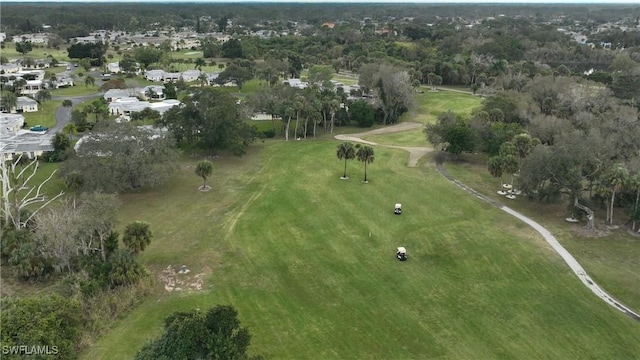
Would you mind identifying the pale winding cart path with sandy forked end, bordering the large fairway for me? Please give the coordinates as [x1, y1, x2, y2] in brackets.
[335, 122, 640, 322]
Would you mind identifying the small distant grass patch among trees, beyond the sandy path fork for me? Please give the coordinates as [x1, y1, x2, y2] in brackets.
[412, 87, 482, 123]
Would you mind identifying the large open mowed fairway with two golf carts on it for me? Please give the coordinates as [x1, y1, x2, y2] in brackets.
[82, 140, 640, 360]
